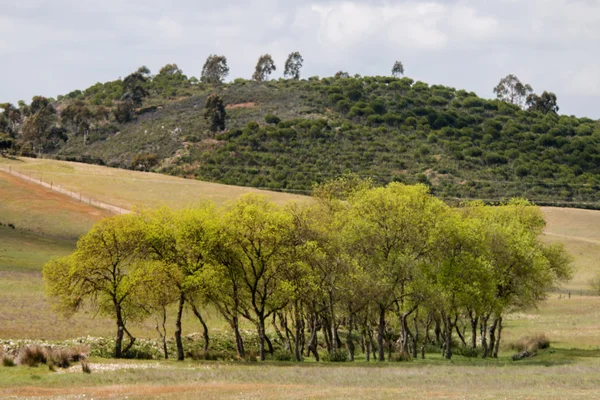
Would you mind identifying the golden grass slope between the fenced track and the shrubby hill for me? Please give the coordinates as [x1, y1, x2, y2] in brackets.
[0, 158, 308, 208]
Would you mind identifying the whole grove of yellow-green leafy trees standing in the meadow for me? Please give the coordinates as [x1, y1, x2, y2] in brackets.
[43, 180, 571, 361]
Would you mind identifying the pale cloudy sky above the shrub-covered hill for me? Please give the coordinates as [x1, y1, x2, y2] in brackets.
[0, 0, 600, 119]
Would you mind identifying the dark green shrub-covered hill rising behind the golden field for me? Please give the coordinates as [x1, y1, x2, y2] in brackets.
[0, 70, 600, 208]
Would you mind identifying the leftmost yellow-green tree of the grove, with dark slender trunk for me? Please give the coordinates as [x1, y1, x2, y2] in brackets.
[42, 214, 151, 358]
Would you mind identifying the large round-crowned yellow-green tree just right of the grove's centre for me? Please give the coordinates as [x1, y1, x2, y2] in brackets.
[346, 183, 447, 361]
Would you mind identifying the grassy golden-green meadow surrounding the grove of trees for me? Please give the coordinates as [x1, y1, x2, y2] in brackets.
[0, 158, 600, 399]
